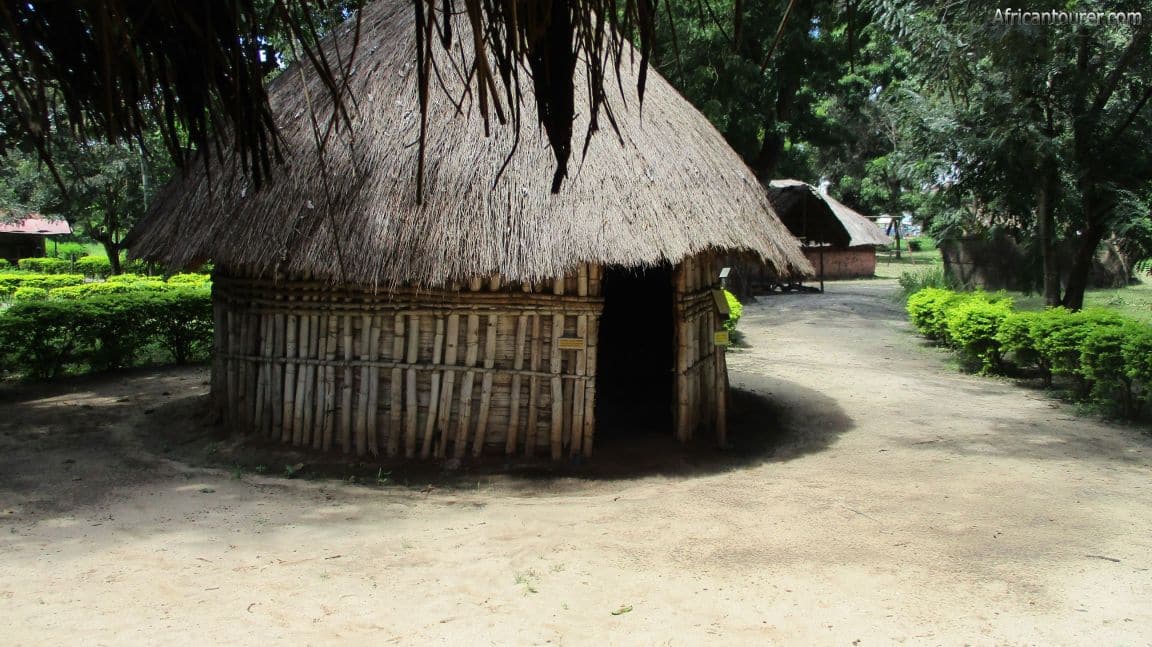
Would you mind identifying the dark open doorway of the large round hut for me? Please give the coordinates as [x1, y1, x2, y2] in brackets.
[596, 264, 676, 442]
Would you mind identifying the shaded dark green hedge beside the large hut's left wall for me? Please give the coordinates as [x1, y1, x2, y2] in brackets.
[0, 287, 212, 379]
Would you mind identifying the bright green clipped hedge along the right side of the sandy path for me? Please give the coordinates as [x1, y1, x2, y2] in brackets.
[907, 288, 1152, 417]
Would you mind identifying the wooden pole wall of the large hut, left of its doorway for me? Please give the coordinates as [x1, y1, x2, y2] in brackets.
[213, 265, 602, 458]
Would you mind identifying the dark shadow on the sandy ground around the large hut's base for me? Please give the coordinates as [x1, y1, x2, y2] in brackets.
[0, 370, 852, 513]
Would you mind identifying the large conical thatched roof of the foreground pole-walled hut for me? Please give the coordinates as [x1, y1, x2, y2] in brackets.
[131, 0, 811, 288]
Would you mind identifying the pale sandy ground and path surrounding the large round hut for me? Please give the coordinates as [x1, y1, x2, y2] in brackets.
[0, 281, 1152, 645]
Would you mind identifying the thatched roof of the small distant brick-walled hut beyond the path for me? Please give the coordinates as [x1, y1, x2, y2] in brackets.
[768, 180, 892, 248]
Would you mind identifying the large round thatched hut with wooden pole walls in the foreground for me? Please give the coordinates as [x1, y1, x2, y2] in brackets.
[131, 0, 811, 457]
